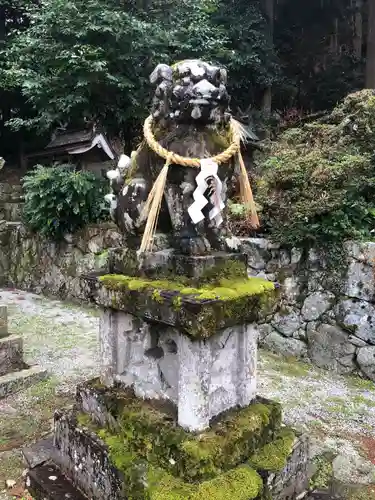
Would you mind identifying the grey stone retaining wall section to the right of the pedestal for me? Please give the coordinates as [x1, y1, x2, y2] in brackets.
[243, 238, 375, 380]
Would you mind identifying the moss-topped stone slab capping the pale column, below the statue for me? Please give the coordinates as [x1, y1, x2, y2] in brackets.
[89, 275, 277, 338]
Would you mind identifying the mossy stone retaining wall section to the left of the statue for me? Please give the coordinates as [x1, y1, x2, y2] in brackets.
[0, 221, 122, 300]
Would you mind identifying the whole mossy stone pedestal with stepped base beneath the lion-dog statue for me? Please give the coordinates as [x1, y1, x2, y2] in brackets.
[25, 250, 308, 500]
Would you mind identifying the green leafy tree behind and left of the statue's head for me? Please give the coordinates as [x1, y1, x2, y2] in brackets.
[3, 0, 271, 139]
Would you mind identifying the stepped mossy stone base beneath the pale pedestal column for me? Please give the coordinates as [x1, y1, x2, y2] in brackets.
[25, 380, 308, 500]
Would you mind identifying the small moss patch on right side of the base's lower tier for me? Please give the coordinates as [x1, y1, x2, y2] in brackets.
[248, 428, 296, 472]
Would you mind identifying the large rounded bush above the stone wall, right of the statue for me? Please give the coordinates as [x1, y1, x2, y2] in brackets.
[257, 90, 375, 247]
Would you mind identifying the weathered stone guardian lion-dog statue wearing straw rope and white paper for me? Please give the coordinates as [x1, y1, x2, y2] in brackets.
[106, 60, 257, 255]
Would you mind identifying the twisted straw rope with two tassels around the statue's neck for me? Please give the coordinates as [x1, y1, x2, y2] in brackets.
[139, 116, 259, 253]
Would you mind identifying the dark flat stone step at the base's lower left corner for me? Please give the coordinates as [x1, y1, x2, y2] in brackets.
[26, 462, 88, 500]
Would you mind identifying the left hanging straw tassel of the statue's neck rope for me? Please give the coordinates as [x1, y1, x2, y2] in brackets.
[139, 156, 171, 253]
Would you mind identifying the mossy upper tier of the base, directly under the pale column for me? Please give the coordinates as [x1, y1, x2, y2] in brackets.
[77, 381, 281, 482]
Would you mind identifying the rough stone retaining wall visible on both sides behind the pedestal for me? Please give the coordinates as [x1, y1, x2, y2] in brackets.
[0, 221, 375, 380]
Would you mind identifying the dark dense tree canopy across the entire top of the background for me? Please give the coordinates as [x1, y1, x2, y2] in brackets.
[0, 0, 375, 154]
